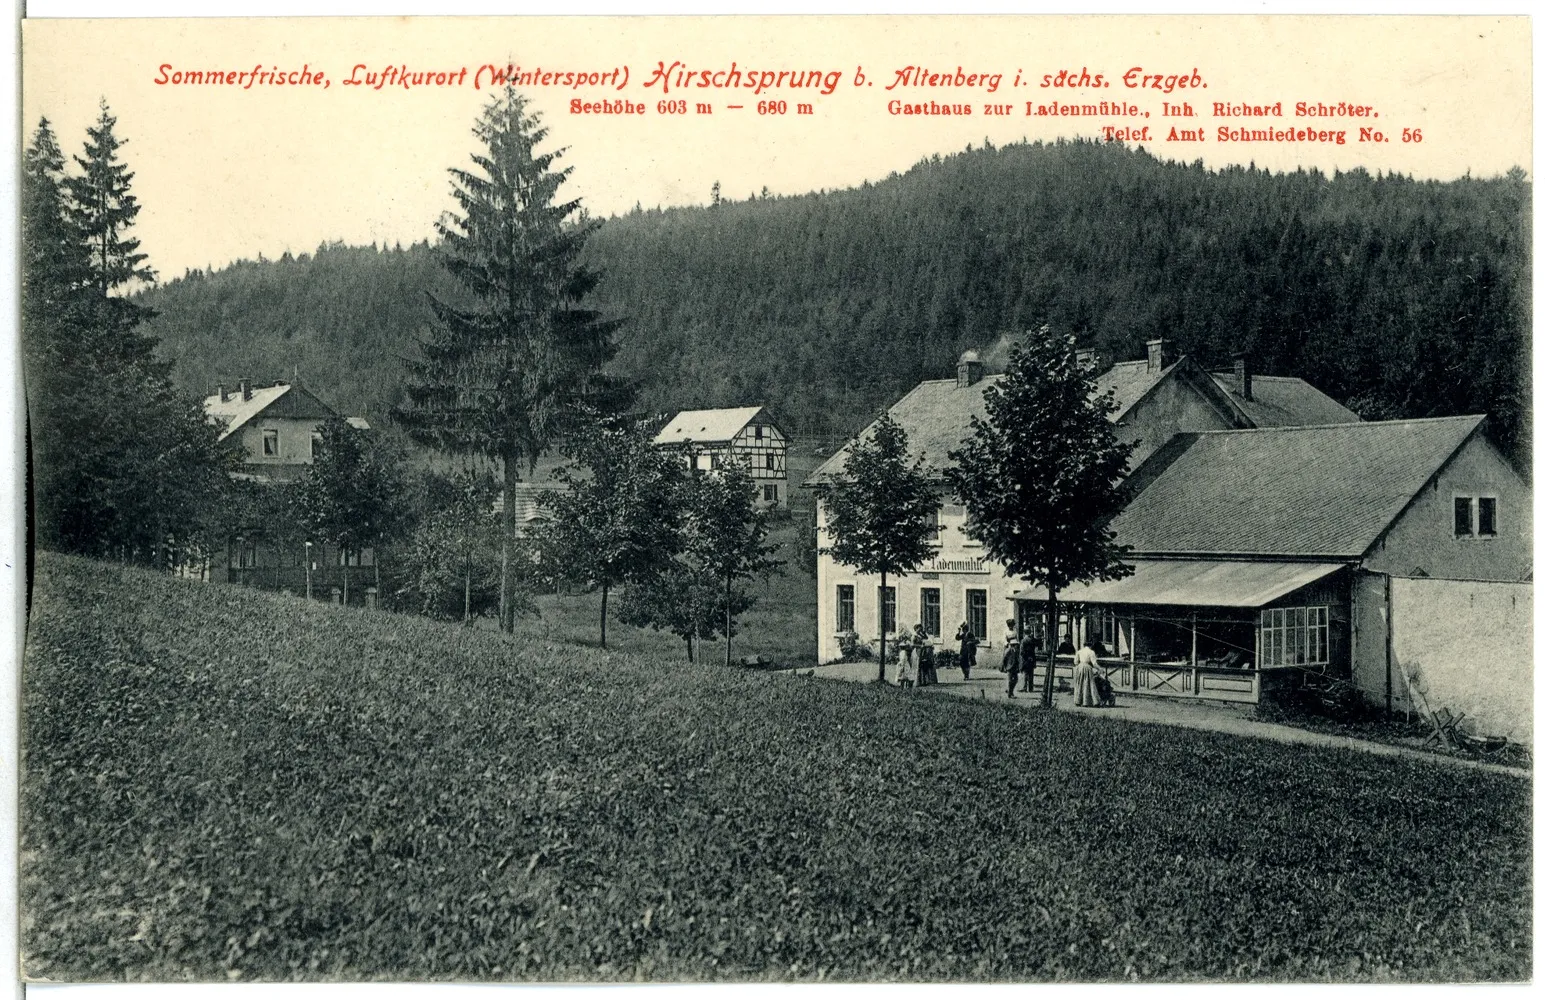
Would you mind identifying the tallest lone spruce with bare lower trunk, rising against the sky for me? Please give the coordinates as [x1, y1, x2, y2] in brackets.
[396, 88, 624, 631]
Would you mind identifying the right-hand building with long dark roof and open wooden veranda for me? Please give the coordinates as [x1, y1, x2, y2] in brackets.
[1014, 416, 1533, 711]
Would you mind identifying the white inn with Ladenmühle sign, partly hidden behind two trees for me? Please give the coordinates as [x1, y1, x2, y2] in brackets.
[806, 338, 1358, 663]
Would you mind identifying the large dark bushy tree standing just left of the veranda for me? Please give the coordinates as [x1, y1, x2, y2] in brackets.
[944, 326, 1132, 706]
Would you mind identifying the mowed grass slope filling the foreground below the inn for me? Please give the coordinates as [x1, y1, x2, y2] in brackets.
[22, 553, 1531, 980]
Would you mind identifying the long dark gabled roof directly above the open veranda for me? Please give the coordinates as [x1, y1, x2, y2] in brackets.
[1111, 416, 1485, 560]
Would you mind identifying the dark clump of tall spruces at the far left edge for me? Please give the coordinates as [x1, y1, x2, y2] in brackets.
[22, 112, 227, 566]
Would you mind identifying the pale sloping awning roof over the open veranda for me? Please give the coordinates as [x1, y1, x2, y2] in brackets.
[1009, 560, 1343, 607]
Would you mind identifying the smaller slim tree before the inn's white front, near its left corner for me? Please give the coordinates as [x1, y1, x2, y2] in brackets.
[816, 413, 939, 680]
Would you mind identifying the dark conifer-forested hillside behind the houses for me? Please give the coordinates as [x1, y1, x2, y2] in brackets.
[135, 142, 1531, 457]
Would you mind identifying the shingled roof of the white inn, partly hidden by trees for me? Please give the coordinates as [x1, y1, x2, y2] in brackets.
[805, 357, 1190, 484]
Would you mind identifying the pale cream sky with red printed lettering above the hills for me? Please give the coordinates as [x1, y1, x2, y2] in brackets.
[22, 17, 1533, 278]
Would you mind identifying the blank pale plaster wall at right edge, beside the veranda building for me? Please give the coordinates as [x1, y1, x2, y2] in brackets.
[1392, 578, 1534, 745]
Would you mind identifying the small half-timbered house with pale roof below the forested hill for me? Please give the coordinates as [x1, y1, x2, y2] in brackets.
[655, 406, 788, 507]
